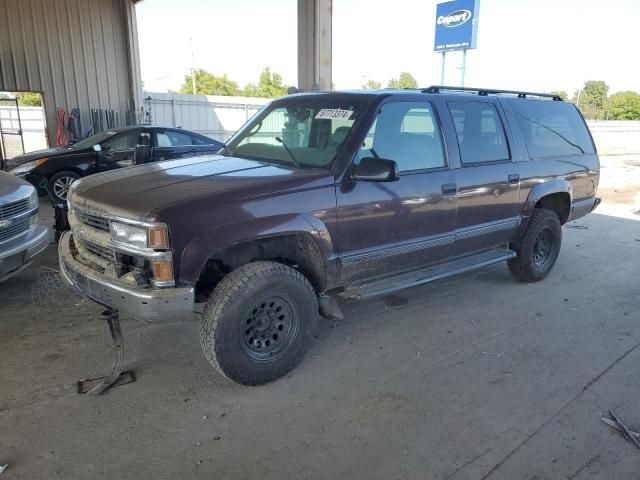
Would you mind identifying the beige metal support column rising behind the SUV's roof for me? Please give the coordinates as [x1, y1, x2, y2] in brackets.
[298, 0, 333, 91]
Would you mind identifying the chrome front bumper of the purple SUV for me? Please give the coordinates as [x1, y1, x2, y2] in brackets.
[58, 232, 194, 322]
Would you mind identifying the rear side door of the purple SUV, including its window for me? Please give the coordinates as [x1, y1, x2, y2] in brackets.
[447, 98, 520, 255]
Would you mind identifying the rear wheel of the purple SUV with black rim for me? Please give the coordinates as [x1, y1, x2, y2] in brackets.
[507, 208, 562, 283]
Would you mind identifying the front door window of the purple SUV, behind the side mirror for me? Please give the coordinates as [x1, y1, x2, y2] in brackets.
[358, 102, 446, 172]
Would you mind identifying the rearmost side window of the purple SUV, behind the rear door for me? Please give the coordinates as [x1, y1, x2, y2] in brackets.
[512, 100, 594, 158]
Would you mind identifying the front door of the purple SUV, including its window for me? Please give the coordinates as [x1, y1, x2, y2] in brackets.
[336, 101, 457, 284]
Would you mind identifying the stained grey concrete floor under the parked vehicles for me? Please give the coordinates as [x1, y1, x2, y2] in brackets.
[0, 157, 640, 480]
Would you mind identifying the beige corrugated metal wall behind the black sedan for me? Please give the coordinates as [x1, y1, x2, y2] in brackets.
[0, 0, 140, 145]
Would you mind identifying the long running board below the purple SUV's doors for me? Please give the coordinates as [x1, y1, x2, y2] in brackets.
[340, 248, 516, 300]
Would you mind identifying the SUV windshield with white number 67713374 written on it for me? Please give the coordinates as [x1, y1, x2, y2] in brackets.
[225, 95, 366, 168]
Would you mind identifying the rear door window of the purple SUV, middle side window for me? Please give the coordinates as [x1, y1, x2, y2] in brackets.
[448, 102, 510, 165]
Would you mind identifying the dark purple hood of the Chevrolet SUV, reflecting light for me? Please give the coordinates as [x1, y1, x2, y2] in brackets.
[71, 155, 333, 220]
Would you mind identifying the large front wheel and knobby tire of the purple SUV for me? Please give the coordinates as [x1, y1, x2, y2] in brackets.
[200, 261, 318, 385]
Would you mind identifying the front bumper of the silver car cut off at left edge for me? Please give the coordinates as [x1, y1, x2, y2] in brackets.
[0, 225, 49, 282]
